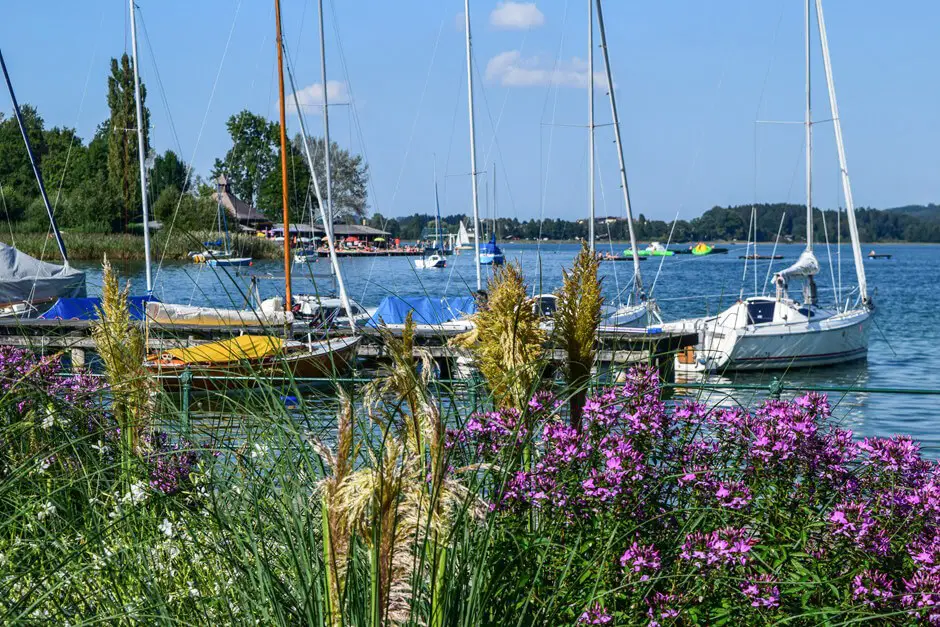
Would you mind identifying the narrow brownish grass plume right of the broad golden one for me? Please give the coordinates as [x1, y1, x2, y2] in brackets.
[555, 243, 604, 432]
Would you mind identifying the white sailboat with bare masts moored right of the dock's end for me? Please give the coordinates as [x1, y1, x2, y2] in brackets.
[664, 0, 873, 371]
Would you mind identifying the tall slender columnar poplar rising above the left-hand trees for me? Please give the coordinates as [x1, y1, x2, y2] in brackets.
[108, 53, 150, 229]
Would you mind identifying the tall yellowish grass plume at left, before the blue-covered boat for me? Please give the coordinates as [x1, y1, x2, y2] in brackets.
[91, 256, 152, 452]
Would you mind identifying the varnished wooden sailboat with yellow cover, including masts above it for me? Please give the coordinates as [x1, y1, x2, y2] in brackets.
[147, 0, 360, 388]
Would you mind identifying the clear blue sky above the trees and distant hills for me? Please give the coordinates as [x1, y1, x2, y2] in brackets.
[0, 0, 940, 220]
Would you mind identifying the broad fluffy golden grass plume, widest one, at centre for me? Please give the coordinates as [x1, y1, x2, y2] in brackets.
[454, 263, 546, 411]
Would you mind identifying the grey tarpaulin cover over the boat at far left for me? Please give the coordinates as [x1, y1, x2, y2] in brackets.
[0, 243, 85, 306]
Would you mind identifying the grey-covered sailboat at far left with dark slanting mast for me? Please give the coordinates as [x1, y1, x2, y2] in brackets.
[0, 47, 85, 317]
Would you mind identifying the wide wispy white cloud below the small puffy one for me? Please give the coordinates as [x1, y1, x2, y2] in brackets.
[486, 50, 607, 89]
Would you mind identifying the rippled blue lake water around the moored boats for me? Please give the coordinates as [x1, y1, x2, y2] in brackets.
[76, 244, 940, 456]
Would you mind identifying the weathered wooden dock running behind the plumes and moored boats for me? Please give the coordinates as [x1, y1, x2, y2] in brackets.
[0, 318, 698, 383]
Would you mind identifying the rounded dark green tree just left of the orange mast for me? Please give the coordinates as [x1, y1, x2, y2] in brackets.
[212, 110, 280, 206]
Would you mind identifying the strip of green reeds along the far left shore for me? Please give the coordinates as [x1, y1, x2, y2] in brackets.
[0, 231, 283, 261]
